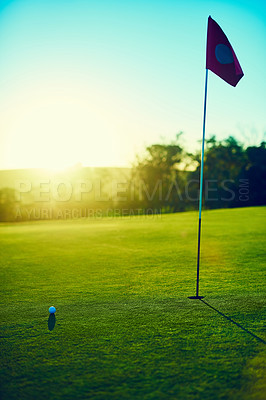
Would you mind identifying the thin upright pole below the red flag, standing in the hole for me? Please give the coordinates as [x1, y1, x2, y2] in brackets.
[189, 68, 208, 299]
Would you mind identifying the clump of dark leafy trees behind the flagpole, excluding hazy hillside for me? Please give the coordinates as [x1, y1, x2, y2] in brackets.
[132, 135, 266, 212]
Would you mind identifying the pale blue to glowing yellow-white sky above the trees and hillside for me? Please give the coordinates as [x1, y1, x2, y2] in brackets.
[0, 0, 266, 169]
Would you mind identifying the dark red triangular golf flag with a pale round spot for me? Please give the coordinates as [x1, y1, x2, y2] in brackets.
[206, 17, 244, 86]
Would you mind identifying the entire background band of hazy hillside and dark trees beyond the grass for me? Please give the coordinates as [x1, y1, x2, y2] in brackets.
[0, 134, 266, 221]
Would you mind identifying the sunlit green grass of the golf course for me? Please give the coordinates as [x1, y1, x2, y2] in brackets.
[0, 207, 266, 400]
